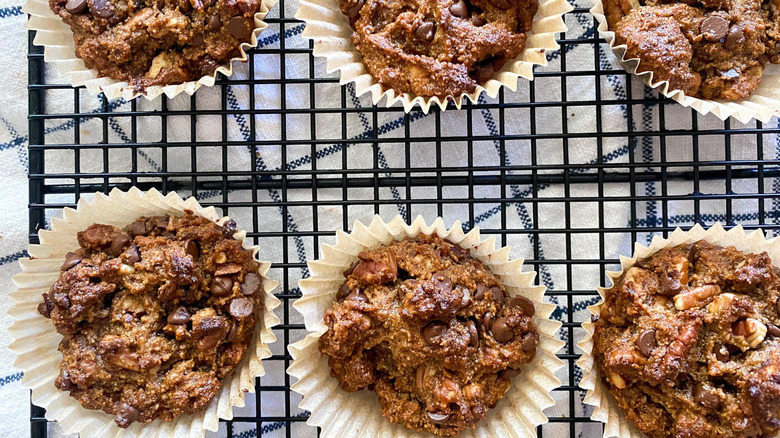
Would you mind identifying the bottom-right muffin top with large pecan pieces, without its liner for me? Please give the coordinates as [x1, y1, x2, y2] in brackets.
[593, 241, 780, 438]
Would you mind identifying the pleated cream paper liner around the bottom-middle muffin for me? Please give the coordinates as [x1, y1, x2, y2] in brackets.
[287, 216, 564, 438]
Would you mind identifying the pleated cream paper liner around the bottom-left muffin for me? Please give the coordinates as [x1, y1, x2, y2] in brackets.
[8, 188, 280, 437]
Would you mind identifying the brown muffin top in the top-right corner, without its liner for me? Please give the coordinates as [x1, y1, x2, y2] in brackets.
[604, 0, 780, 100]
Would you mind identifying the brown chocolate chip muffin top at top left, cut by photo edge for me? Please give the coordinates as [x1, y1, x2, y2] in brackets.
[49, 0, 262, 91]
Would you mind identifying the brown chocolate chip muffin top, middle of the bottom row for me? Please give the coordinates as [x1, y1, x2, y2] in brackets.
[319, 234, 539, 436]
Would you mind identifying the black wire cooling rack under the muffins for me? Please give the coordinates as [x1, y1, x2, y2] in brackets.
[29, 0, 780, 438]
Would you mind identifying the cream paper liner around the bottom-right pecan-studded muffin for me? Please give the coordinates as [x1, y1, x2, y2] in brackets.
[577, 223, 780, 438]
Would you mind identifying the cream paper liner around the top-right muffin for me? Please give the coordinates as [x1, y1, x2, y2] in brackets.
[590, 0, 780, 123]
